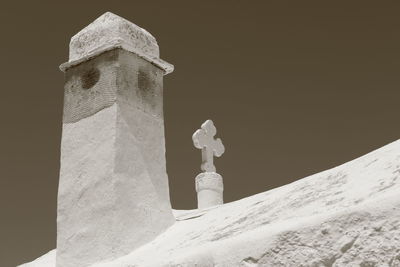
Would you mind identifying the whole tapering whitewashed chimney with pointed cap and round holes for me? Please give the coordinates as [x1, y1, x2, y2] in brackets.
[57, 12, 174, 267]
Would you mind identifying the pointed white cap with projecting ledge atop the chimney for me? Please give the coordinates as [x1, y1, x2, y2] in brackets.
[60, 12, 174, 74]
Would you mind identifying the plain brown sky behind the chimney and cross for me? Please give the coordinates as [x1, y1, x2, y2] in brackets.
[0, 1, 400, 267]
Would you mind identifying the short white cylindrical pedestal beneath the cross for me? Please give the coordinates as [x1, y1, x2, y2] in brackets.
[196, 172, 224, 209]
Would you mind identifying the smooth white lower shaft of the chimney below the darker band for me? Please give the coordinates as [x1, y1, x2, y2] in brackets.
[57, 104, 174, 267]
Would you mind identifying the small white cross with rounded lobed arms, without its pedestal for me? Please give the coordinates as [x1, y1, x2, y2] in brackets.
[192, 120, 225, 172]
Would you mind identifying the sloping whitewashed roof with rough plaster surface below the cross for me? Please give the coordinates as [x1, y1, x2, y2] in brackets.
[20, 141, 400, 267]
